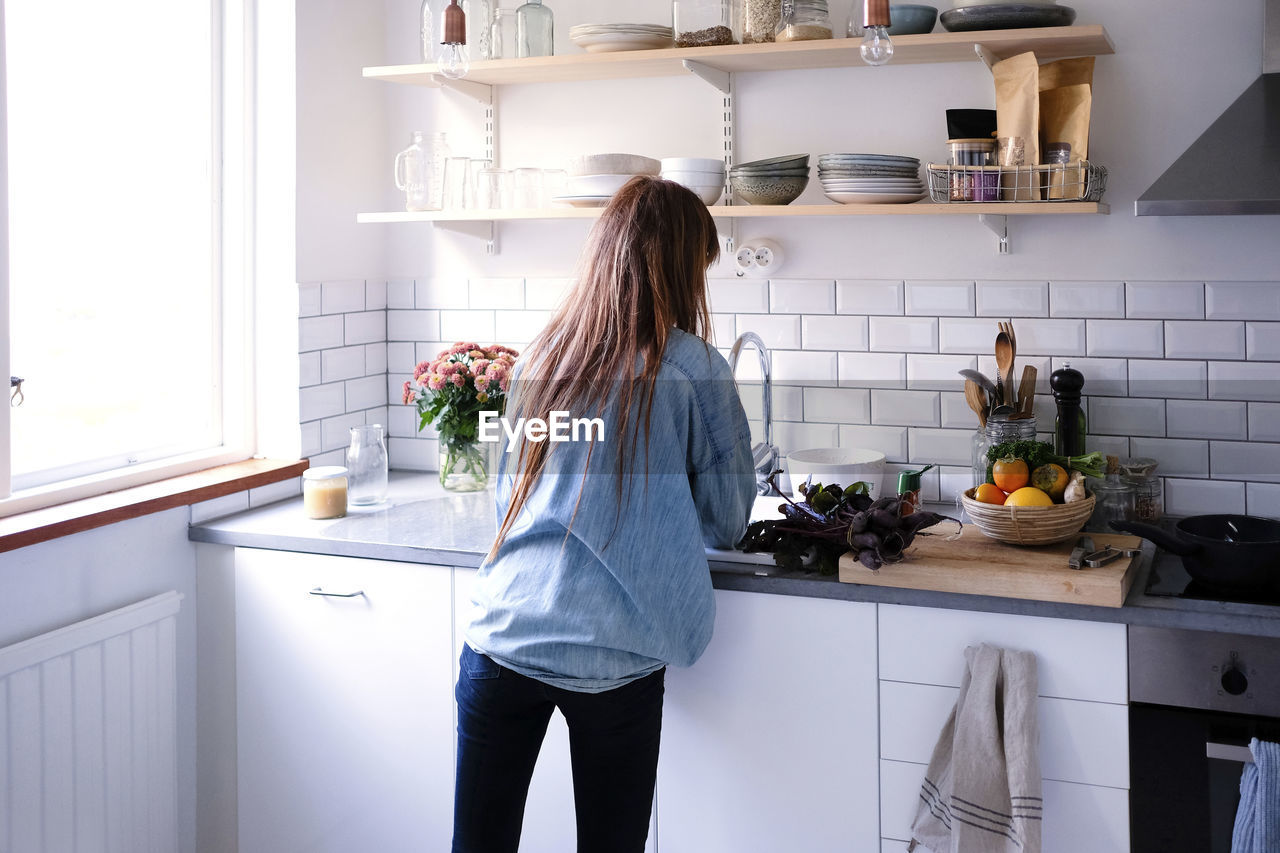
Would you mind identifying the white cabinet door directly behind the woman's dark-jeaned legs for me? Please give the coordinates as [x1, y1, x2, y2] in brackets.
[453, 567, 655, 853]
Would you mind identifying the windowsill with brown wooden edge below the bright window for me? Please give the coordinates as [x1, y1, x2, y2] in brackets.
[0, 459, 310, 552]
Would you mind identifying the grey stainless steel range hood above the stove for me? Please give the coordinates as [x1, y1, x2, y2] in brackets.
[1134, 0, 1280, 216]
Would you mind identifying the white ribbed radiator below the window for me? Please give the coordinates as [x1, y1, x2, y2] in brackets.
[0, 592, 182, 853]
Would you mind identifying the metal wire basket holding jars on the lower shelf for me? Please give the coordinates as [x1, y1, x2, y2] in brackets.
[928, 160, 1107, 204]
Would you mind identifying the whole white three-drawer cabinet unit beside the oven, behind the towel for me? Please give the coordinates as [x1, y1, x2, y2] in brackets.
[878, 605, 1129, 853]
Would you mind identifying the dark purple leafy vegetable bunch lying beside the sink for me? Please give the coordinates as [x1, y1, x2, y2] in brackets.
[737, 470, 960, 575]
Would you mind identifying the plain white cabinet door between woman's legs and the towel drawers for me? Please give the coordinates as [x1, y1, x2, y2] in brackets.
[658, 590, 879, 853]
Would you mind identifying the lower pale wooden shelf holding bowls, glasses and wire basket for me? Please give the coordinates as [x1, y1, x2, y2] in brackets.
[356, 201, 1111, 223]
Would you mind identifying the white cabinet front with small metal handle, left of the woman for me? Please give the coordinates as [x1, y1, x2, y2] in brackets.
[236, 548, 453, 853]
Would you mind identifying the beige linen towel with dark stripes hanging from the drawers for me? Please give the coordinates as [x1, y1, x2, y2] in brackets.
[908, 643, 1039, 853]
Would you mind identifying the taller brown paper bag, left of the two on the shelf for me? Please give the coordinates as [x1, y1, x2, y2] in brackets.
[991, 51, 1039, 201]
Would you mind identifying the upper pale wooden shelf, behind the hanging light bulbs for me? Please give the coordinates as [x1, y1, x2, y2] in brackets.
[364, 24, 1115, 87]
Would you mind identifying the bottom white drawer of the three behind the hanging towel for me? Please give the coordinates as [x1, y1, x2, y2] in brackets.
[881, 761, 1129, 853]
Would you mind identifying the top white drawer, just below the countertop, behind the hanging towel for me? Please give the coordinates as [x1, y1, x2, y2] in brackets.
[879, 605, 1129, 704]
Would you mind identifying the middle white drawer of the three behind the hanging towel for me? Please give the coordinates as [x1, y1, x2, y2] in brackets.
[881, 681, 1129, 788]
